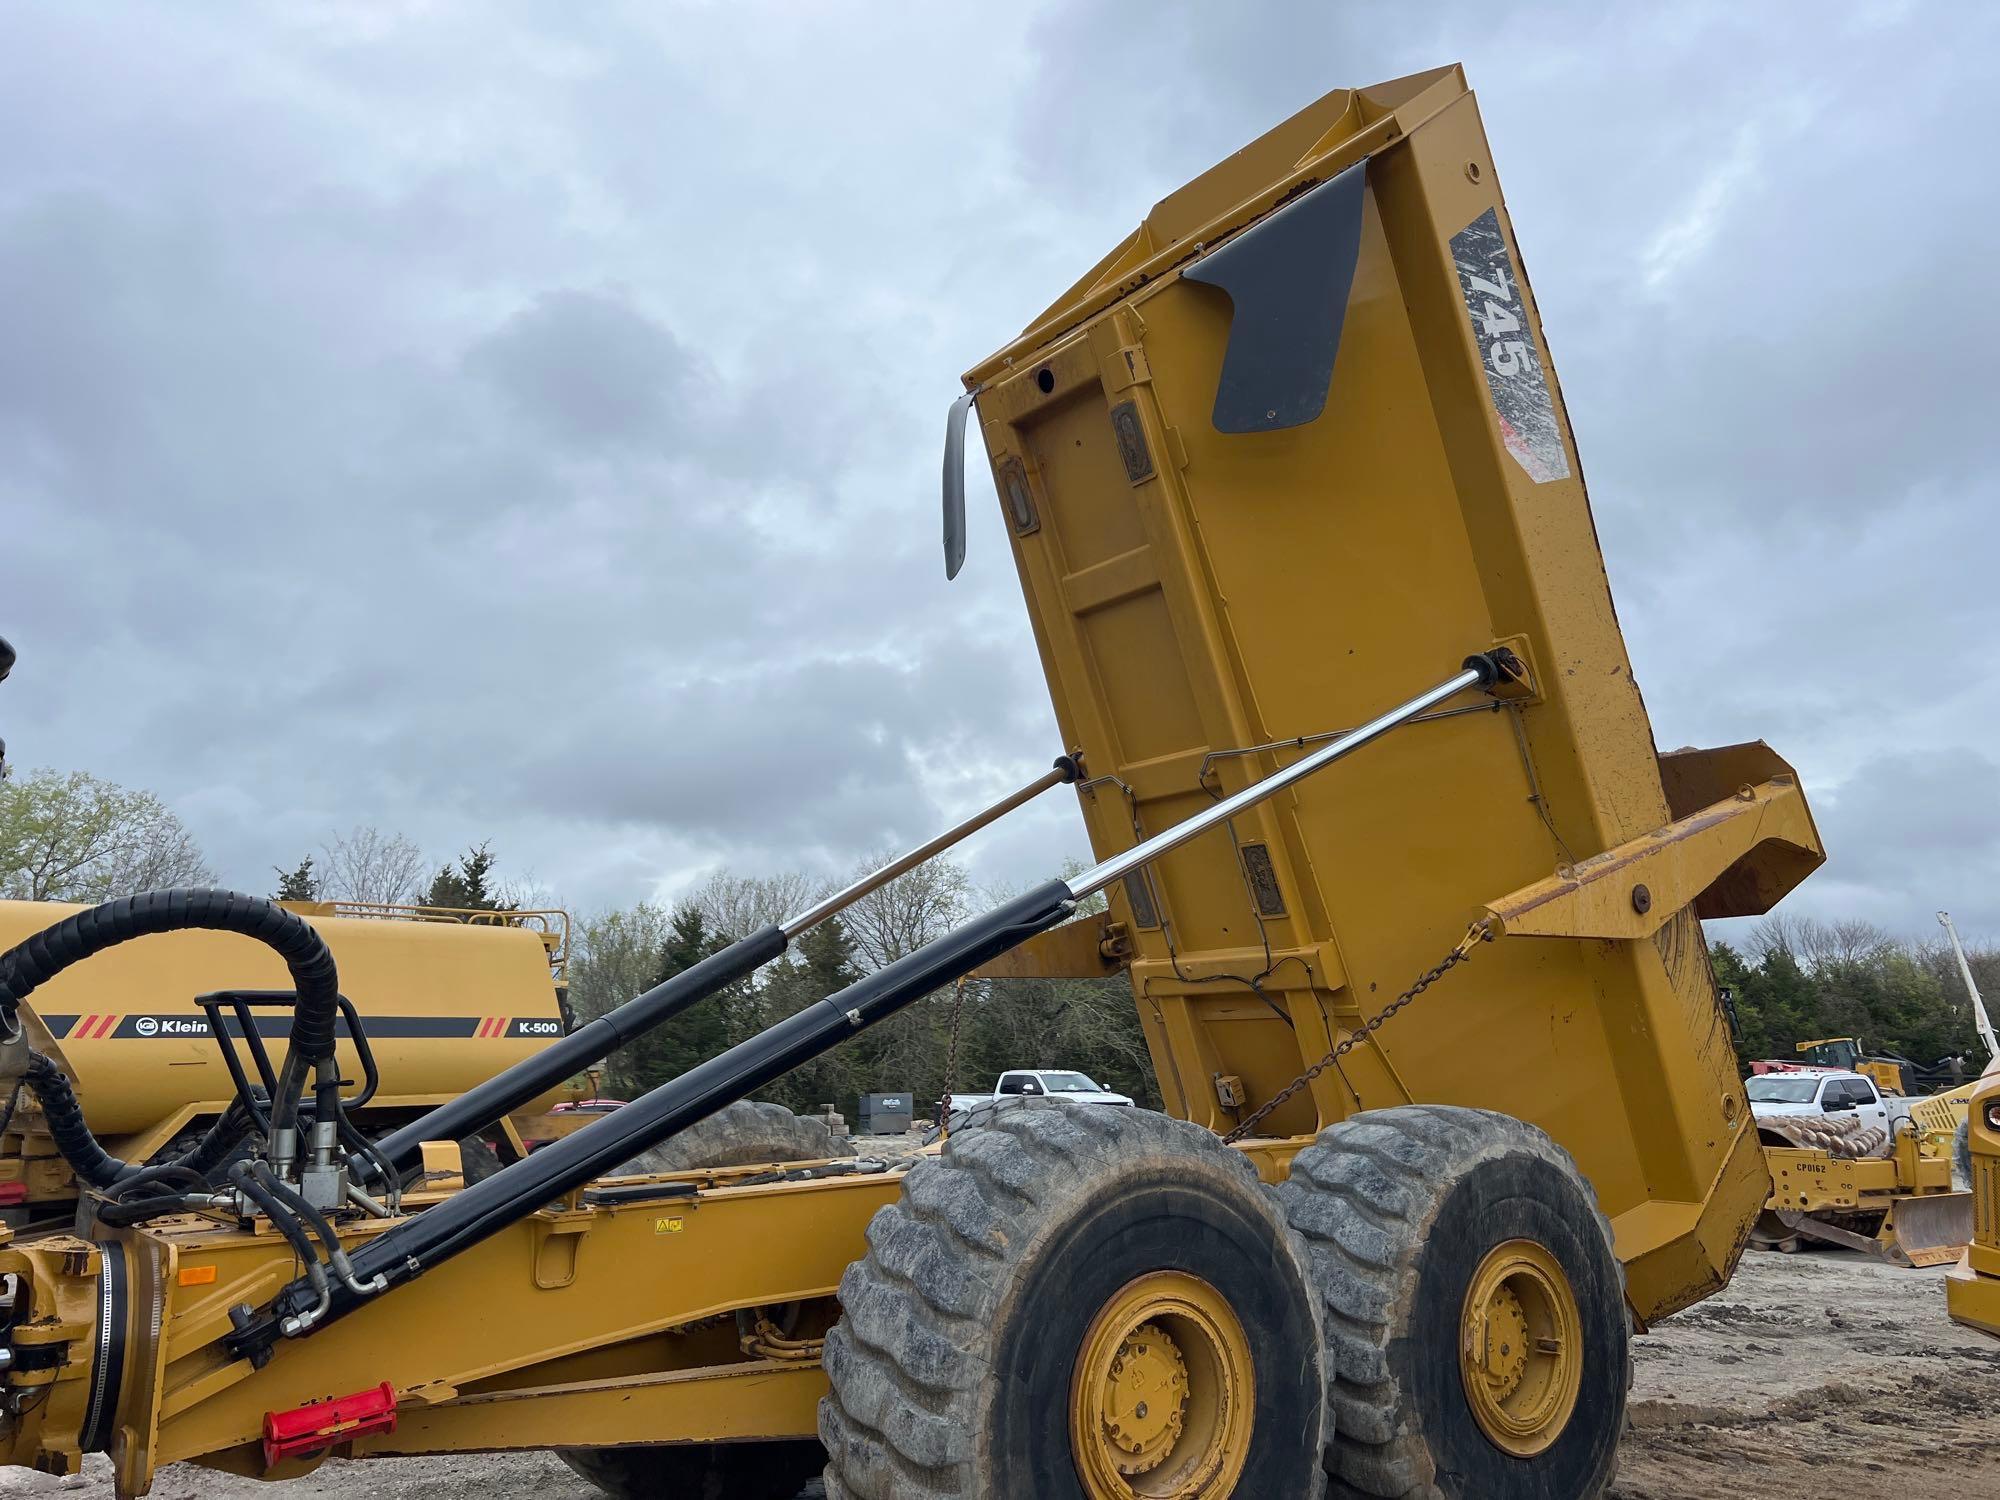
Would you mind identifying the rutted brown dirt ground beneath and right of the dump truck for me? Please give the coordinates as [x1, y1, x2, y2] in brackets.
[0, 1252, 2000, 1500]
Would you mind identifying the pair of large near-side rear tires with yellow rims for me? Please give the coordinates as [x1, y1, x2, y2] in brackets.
[820, 1100, 1630, 1500]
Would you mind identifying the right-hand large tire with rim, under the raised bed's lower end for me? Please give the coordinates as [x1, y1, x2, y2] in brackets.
[1278, 1104, 1632, 1500]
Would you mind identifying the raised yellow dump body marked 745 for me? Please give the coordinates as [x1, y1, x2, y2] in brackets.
[966, 68, 1822, 1318]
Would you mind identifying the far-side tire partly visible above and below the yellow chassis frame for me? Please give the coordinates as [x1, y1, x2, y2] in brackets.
[556, 1100, 854, 1500]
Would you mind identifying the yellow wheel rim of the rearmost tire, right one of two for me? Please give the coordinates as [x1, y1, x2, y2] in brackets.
[1458, 1240, 1584, 1458]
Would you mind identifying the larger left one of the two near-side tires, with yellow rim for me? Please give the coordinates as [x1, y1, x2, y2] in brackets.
[820, 1098, 1322, 1500]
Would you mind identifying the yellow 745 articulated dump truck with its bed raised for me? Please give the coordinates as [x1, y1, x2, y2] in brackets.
[0, 68, 1822, 1500]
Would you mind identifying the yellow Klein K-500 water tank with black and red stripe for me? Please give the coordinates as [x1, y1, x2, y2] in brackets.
[0, 902, 562, 1176]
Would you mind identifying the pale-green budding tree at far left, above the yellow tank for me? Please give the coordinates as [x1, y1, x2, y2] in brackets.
[0, 770, 216, 902]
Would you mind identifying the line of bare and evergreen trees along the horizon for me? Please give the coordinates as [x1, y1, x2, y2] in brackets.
[0, 770, 2000, 1114]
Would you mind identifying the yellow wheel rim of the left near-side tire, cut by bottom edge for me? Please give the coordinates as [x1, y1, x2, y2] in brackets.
[1070, 1270, 1256, 1500]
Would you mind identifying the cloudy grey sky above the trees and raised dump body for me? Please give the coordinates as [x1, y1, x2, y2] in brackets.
[0, 0, 2000, 936]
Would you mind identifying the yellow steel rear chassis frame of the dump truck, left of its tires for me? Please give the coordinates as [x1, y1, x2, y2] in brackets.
[0, 1168, 902, 1492]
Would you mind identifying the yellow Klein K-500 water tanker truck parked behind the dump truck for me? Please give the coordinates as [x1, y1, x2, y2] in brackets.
[0, 902, 568, 1232]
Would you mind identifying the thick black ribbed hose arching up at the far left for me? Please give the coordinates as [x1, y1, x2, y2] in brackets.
[0, 890, 340, 1188]
